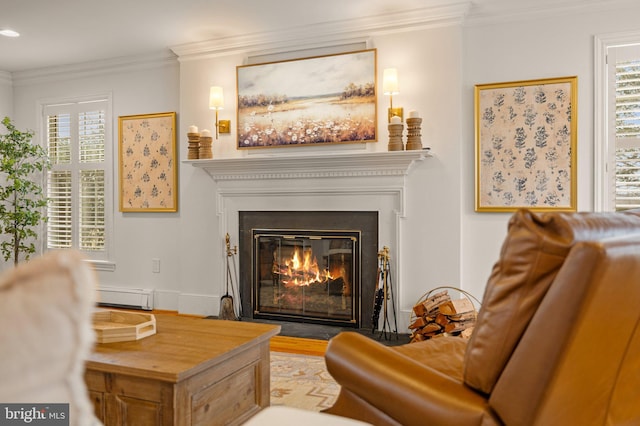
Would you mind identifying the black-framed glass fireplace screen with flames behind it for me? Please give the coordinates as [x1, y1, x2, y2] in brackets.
[252, 229, 360, 326]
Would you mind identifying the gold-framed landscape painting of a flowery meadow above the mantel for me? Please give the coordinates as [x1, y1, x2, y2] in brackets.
[236, 49, 377, 149]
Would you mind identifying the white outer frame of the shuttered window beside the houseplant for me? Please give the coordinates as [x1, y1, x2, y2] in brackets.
[38, 92, 115, 271]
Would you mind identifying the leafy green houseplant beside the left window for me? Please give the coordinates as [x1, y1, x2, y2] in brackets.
[0, 117, 50, 265]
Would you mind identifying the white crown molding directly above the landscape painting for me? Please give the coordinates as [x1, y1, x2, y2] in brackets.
[170, 0, 471, 61]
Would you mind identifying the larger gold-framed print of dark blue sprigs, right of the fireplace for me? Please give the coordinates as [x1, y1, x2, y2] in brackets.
[474, 76, 578, 212]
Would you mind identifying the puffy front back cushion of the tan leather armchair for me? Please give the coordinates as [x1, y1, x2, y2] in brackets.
[464, 210, 640, 394]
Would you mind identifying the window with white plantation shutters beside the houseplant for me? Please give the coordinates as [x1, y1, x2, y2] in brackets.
[43, 98, 112, 261]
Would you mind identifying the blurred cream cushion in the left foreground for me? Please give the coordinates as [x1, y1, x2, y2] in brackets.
[0, 251, 98, 426]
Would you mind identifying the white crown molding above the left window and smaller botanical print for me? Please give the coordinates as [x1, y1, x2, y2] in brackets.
[12, 49, 177, 86]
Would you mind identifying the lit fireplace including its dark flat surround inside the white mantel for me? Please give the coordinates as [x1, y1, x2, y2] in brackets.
[239, 211, 378, 327]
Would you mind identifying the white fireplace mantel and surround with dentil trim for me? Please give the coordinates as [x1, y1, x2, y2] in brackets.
[184, 150, 430, 330]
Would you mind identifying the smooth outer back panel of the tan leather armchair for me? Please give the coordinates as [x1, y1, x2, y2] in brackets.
[489, 233, 640, 426]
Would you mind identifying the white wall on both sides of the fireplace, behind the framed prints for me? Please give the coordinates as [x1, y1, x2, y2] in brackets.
[8, 3, 640, 315]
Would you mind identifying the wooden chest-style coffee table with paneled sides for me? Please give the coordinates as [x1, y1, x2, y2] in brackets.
[85, 314, 280, 426]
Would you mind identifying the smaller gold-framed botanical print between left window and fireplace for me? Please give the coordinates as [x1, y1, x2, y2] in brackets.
[118, 112, 178, 212]
